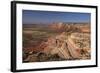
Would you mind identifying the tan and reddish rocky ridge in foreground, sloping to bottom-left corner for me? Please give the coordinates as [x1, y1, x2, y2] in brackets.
[24, 32, 89, 62]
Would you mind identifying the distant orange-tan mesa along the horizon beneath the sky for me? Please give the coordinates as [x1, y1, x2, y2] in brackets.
[49, 22, 90, 32]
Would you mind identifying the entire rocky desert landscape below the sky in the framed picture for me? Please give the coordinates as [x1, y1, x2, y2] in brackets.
[22, 22, 91, 63]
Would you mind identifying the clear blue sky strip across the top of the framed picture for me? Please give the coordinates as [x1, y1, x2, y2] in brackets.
[22, 10, 91, 24]
